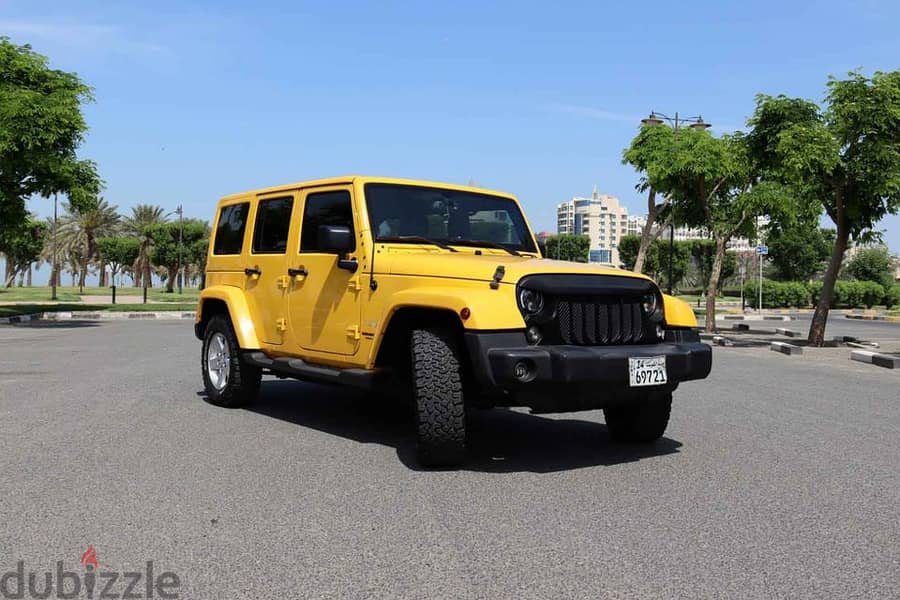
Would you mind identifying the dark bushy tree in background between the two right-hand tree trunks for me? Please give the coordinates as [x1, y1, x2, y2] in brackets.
[766, 223, 834, 281]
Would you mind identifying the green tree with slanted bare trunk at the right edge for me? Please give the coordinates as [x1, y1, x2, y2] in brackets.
[751, 71, 900, 346]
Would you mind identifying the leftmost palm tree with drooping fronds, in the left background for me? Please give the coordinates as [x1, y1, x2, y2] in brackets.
[57, 198, 121, 288]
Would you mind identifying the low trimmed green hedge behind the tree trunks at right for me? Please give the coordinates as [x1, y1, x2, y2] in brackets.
[744, 279, 900, 308]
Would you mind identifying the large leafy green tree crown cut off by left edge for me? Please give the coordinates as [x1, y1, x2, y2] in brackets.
[0, 37, 100, 235]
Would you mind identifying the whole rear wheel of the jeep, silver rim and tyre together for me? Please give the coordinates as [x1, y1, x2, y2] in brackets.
[200, 315, 262, 408]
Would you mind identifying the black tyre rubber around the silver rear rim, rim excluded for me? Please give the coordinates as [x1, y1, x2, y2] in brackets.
[200, 315, 262, 408]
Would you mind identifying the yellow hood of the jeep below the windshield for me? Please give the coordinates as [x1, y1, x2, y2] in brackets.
[375, 250, 648, 284]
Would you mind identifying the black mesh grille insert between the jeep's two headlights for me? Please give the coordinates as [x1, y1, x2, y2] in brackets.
[548, 296, 651, 346]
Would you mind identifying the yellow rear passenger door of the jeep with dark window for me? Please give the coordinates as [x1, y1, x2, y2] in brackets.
[244, 192, 299, 345]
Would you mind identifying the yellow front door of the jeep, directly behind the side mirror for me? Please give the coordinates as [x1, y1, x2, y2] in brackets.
[288, 186, 362, 355]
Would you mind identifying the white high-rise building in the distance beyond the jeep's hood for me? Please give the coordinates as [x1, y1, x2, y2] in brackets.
[556, 187, 628, 267]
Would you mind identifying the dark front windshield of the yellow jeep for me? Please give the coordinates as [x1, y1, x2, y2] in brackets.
[365, 183, 537, 253]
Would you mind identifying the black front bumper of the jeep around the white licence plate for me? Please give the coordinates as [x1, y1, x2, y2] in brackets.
[466, 330, 712, 404]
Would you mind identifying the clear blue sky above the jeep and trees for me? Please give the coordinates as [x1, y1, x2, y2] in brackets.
[0, 0, 900, 252]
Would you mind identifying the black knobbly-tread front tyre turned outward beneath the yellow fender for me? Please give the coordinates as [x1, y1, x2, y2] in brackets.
[410, 329, 466, 467]
